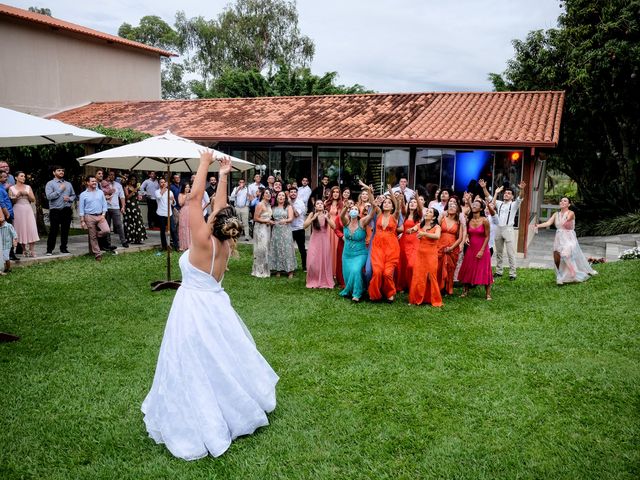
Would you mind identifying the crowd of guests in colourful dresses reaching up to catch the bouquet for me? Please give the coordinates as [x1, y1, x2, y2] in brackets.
[248, 175, 526, 306]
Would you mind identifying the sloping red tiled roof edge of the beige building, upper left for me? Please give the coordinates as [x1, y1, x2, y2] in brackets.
[0, 3, 176, 57]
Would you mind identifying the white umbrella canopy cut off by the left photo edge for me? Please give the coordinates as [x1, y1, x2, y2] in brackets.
[0, 107, 104, 147]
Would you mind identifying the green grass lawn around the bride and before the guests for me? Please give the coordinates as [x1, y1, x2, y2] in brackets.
[0, 247, 640, 479]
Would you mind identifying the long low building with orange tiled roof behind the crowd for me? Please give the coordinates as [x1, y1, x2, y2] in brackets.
[55, 91, 564, 253]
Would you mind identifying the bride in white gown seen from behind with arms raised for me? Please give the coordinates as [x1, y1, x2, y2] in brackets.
[142, 152, 278, 460]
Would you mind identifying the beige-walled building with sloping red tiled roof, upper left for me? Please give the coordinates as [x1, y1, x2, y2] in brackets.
[0, 4, 174, 116]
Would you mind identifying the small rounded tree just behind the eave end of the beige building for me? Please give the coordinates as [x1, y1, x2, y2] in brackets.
[118, 15, 189, 98]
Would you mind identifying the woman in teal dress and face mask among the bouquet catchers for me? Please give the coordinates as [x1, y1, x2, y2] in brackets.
[340, 200, 373, 303]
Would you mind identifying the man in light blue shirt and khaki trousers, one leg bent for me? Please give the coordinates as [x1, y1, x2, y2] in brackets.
[78, 175, 110, 262]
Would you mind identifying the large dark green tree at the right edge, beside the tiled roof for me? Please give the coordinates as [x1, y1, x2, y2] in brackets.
[489, 0, 640, 215]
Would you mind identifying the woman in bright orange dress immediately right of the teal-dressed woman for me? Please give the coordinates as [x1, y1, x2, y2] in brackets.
[369, 186, 402, 302]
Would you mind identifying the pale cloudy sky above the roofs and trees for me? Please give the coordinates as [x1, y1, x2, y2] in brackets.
[8, 0, 561, 93]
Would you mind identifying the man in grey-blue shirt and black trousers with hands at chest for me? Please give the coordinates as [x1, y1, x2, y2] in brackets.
[44, 165, 76, 256]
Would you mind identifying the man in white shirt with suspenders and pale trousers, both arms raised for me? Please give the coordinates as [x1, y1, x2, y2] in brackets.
[478, 180, 527, 280]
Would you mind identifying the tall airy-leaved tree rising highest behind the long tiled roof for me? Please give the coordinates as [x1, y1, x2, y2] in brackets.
[176, 0, 315, 90]
